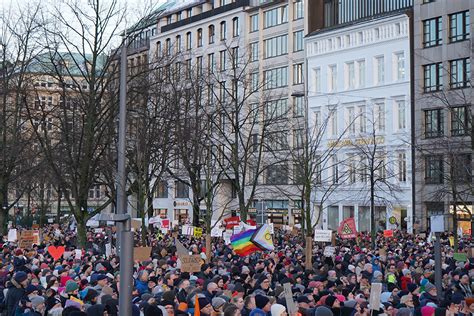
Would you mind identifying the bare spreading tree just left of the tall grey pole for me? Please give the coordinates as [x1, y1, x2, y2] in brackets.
[29, 0, 125, 246]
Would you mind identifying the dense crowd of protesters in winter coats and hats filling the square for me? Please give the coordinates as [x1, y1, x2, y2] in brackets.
[0, 226, 474, 316]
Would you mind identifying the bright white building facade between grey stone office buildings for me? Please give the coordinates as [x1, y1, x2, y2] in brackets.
[305, 14, 413, 231]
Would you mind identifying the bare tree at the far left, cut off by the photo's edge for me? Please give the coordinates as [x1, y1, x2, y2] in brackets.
[0, 3, 41, 234]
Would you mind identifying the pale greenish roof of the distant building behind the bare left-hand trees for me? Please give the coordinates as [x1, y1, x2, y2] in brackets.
[26, 52, 107, 76]
